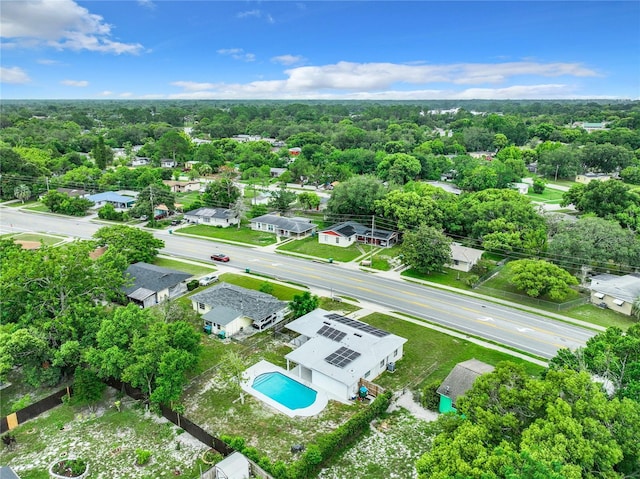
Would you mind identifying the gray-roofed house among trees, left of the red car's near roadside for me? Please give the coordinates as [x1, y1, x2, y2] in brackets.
[123, 262, 191, 308]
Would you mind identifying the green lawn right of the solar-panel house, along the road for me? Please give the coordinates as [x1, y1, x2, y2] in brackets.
[358, 313, 544, 390]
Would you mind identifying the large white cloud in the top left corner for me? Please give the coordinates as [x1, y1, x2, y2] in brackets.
[0, 0, 143, 55]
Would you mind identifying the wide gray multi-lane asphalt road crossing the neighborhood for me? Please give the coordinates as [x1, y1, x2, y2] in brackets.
[0, 208, 595, 359]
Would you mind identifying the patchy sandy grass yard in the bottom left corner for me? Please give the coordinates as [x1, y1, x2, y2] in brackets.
[0, 387, 209, 479]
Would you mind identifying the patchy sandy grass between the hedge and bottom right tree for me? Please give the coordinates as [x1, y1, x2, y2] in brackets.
[318, 409, 431, 479]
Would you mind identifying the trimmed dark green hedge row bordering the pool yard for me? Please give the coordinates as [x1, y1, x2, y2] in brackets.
[221, 392, 391, 479]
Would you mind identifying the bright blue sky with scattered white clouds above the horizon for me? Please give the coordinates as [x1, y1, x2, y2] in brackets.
[0, 0, 640, 100]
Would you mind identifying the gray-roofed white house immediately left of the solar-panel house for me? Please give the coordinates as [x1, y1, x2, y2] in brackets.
[190, 283, 287, 336]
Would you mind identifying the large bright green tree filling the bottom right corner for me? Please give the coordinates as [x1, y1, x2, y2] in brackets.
[416, 363, 640, 479]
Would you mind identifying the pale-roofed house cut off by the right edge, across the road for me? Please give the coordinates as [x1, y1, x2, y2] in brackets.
[589, 273, 640, 316]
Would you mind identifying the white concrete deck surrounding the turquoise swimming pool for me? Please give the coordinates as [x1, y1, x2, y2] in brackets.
[241, 360, 329, 417]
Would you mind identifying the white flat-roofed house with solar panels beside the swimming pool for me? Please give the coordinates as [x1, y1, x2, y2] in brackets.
[285, 309, 407, 400]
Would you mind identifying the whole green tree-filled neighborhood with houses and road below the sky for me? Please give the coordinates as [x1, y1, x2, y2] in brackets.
[0, 100, 640, 479]
